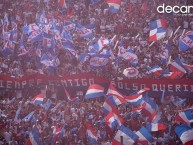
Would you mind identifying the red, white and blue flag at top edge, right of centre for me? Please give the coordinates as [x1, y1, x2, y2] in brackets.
[107, 0, 121, 13]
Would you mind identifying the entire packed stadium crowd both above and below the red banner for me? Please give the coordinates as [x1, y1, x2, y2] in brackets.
[0, 0, 193, 145]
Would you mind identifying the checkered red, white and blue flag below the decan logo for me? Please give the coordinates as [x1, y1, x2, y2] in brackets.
[149, 19, 166, 41]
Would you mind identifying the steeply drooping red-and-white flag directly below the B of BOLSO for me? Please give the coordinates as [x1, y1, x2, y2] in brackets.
[107, 83, 126, 105]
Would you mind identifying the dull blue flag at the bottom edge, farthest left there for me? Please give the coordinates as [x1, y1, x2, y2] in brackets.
[29, 126, 42, 145]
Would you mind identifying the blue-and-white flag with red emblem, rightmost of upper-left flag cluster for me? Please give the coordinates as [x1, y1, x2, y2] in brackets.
[76, 23, 94, 38]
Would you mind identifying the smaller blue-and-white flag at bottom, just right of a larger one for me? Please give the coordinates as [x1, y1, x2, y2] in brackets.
[135, 127, 153, 145]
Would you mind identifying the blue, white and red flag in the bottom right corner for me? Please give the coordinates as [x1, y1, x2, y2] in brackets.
[175, 124, 193, 145]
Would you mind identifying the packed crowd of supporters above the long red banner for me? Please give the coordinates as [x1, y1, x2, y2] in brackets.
[0, 0, 193, 79]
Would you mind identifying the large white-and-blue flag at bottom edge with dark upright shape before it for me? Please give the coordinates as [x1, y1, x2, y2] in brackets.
[112, 125, 139, 145]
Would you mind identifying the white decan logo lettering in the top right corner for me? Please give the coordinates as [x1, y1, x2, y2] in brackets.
[157, 4, 193, 14]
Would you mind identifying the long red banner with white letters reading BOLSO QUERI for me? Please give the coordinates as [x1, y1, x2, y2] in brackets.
[0, 73, 193, 97]
